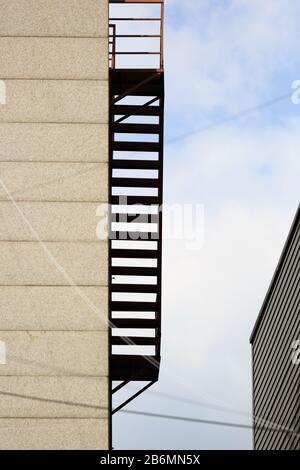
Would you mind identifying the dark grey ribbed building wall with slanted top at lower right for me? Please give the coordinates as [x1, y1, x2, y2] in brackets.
[251, 208, 300, 450]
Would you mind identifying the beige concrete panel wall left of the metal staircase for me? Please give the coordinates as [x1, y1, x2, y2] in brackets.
[0, 0, 108, 449]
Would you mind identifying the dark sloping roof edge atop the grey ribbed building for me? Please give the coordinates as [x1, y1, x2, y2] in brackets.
[250, 203, 300, 344]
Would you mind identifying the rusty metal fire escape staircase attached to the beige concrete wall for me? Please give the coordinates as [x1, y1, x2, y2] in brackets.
[109, 0, 164, 413]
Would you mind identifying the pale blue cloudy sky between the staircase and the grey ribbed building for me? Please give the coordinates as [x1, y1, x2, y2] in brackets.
[114, 0, 300, 449]
